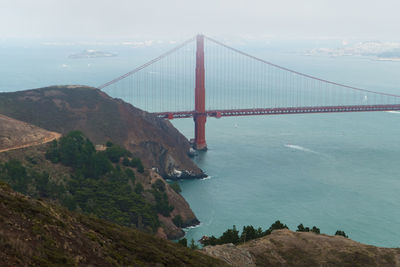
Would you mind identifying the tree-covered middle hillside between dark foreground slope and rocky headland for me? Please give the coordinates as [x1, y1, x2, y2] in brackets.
[0, 132, 199, 239]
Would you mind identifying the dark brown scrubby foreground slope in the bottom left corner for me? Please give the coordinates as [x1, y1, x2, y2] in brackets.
[0, 182, 226, 266]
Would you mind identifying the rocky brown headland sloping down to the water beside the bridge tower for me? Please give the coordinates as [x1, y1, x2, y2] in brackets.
[0, 86, 204, 178]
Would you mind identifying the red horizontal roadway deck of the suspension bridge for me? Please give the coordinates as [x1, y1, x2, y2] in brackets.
[153, 104, 400, 120]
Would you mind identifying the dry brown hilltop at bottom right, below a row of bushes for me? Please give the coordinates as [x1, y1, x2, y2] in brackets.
[203, 230, 400, 267]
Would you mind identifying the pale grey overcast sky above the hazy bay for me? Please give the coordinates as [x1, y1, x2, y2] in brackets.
[0, 0, 400, 41]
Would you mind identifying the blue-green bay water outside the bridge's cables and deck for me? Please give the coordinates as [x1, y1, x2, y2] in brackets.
[0, 37, 400, 247]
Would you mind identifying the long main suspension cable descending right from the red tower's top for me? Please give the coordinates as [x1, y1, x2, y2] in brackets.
[204, 36, 400, 98]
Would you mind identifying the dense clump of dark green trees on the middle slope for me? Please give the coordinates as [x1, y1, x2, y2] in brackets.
[42, 131, 158, 231]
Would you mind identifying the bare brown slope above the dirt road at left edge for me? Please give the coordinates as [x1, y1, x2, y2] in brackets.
[0, 115, 61, 152]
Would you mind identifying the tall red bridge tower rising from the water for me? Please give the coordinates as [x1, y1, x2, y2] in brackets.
[193, 35, 207, 150]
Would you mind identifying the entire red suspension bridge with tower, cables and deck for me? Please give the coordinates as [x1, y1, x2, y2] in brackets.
[98, 35, 400, 150]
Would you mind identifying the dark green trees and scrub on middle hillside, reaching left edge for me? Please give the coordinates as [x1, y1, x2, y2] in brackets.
[0, 131, 174, 232]
